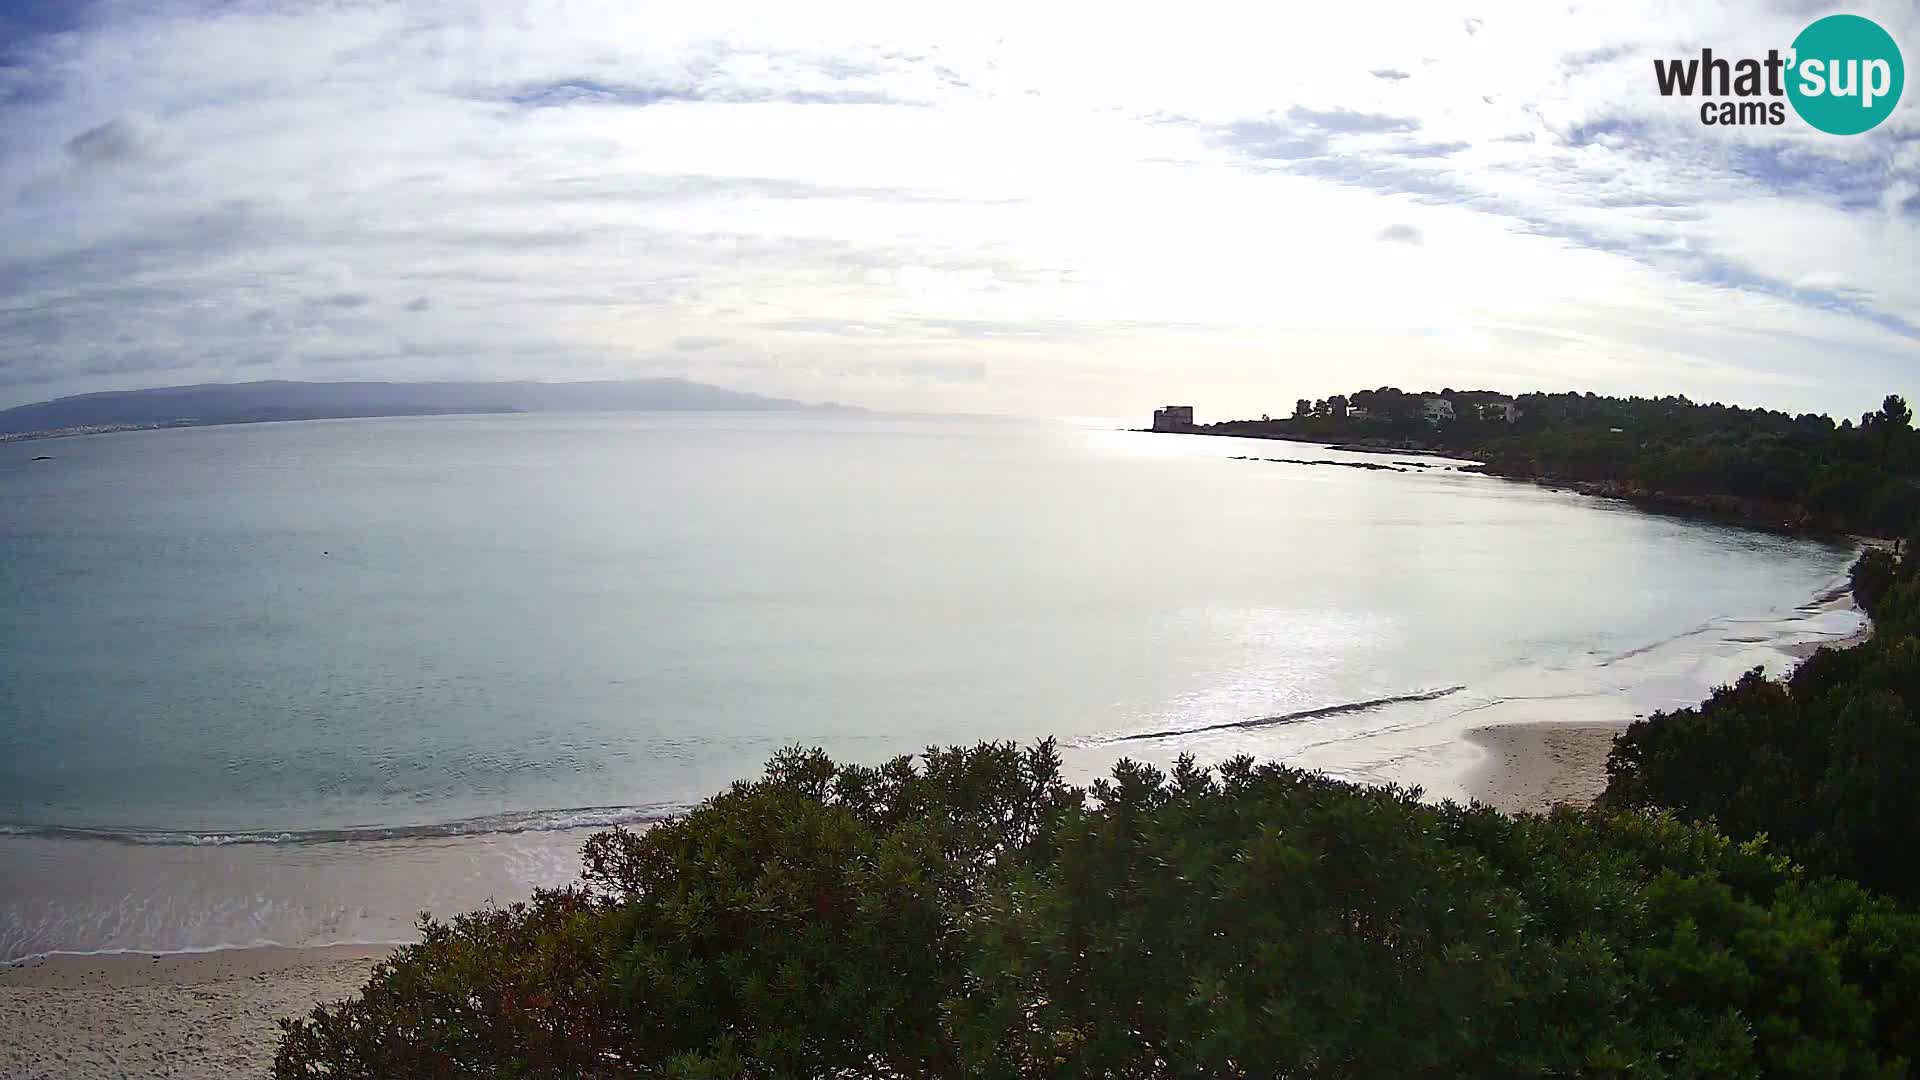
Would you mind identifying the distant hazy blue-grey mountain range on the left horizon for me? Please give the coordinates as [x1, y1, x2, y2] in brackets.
[0, 379, 852, 434]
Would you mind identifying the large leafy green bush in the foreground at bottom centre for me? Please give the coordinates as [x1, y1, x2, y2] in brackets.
[275, 744, 1920, 1078]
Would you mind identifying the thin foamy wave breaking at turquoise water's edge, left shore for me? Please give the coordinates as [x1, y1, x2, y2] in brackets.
[0, 803, 693, 847]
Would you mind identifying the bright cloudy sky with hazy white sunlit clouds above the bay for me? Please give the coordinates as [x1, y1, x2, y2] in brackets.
[0, 0, 1920, 421]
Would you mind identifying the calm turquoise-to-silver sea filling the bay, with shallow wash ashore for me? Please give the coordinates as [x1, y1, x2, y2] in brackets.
[0, 411, 1860, 961]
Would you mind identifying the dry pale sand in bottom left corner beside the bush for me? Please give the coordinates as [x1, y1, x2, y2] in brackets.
[0, 945, 388, 1080]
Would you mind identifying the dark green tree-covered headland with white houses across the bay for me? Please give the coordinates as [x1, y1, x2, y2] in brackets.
[1204, 386, 1920, 536]
